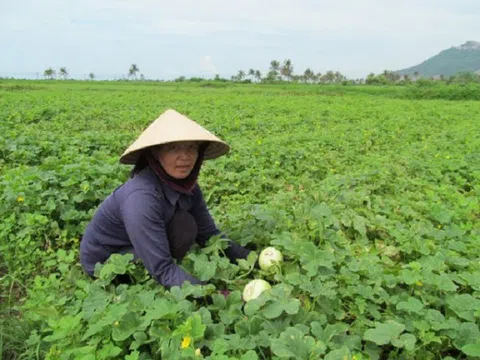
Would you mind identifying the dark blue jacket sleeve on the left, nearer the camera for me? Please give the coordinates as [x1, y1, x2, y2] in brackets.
[120, 190, 202, 288]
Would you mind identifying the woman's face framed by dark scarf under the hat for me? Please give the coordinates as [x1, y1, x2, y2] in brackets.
[153, 141, 199, 179]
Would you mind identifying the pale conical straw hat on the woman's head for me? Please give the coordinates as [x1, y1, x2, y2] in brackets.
[120, 109, 230, 164]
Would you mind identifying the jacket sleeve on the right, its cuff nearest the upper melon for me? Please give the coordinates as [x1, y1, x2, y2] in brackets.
[191, 185, 250, 262]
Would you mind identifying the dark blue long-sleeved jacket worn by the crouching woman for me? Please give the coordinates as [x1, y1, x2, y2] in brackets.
[80, 167, 249, 287]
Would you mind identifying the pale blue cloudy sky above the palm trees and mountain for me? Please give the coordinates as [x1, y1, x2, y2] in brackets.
[0, 0, 480, 80]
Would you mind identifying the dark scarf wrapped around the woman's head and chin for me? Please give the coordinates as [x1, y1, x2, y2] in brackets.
[145, 146, 205, 195]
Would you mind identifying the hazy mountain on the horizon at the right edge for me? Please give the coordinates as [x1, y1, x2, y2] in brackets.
[396, 41, 480, 77]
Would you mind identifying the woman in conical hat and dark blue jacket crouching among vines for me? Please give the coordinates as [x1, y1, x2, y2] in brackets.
[80, 110, 250, 287]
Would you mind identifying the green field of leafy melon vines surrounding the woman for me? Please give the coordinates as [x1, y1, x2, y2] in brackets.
[0, 81, 480, 360]
